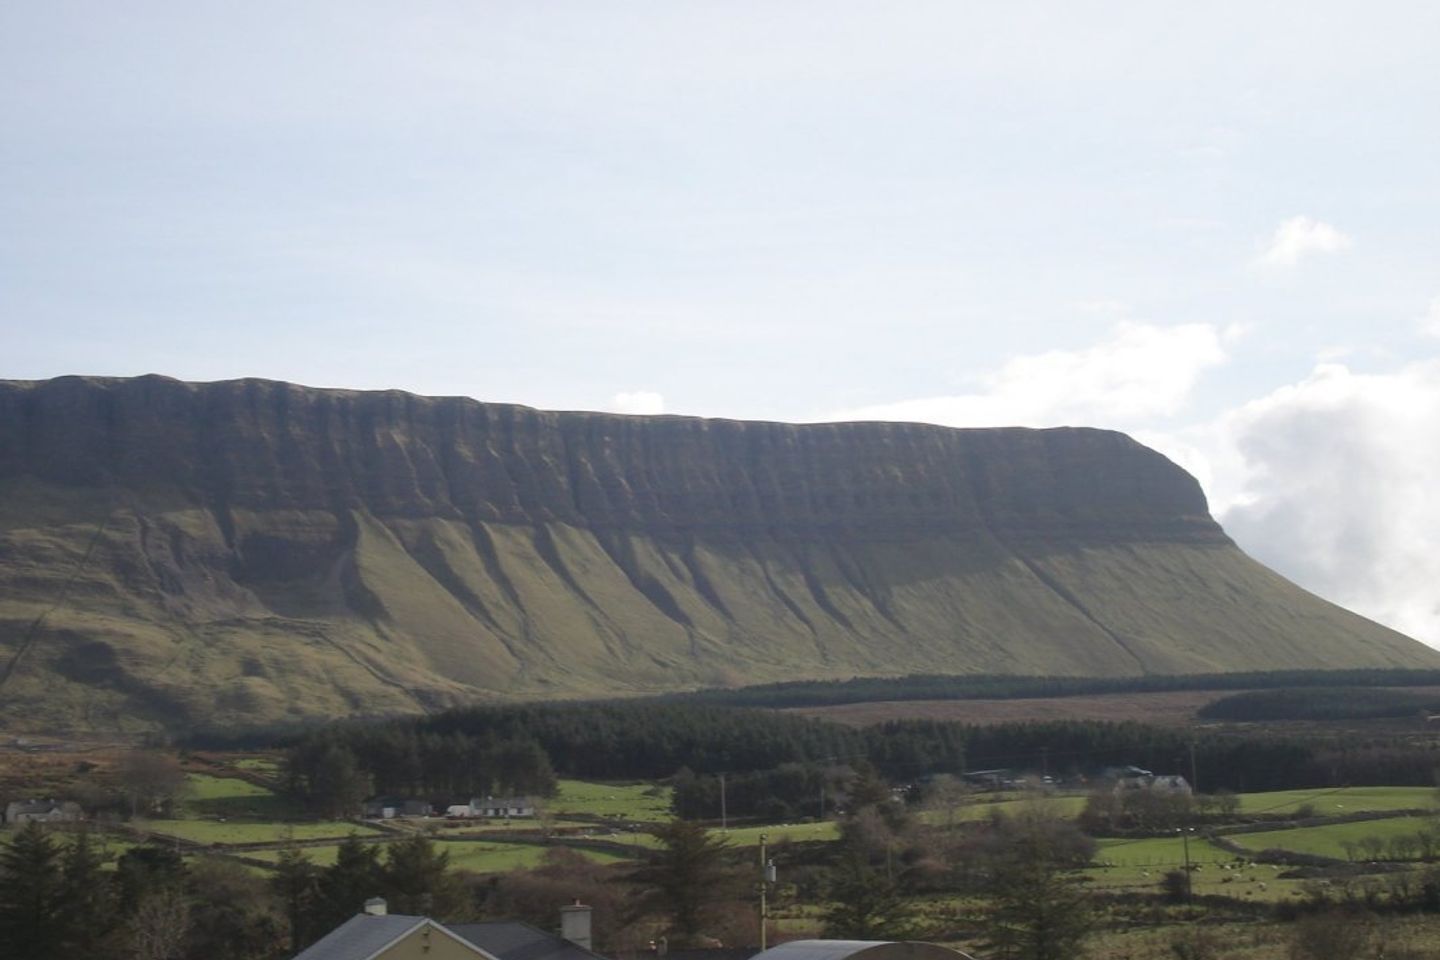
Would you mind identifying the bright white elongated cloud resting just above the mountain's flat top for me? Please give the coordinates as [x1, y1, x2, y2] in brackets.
[824, 322, 1225, 426]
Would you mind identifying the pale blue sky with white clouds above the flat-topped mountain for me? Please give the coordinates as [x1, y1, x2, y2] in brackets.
[0, 0, 1440, 646]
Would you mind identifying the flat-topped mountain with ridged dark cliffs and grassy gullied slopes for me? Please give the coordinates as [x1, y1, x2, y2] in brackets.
[0, 377, 1440, 727]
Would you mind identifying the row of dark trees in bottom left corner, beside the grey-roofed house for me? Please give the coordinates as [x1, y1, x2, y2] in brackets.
[0, 823, 474, 960]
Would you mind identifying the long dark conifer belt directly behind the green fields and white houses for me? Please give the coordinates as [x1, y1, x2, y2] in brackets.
[291, 701, 1440, 818]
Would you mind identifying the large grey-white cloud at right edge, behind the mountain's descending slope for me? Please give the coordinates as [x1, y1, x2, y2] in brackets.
[1139, 361, 1440, 646]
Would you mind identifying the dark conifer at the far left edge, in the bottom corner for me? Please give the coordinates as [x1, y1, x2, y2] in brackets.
[0, 820, 68, 960]
